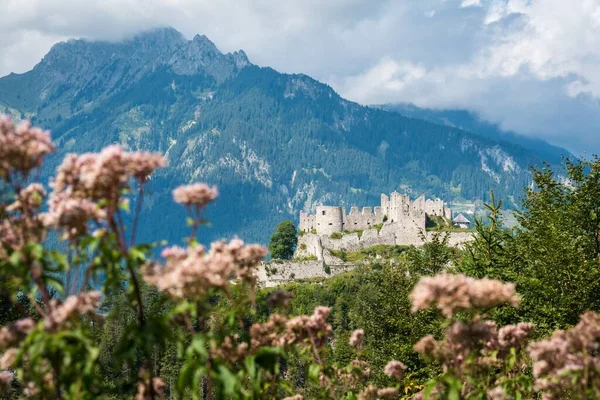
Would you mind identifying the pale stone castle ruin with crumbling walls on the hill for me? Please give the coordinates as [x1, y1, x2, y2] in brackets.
[258, 192, 473, 286]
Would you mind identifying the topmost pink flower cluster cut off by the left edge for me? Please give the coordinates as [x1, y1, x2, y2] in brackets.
[0, 116, 54, 178]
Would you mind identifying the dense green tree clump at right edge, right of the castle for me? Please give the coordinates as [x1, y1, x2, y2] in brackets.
[457, 158, 600, 335]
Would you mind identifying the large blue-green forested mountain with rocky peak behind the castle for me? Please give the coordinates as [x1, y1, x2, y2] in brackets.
[0, 28, 564, 242]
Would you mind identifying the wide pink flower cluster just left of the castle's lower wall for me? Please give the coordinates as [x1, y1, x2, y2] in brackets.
[142, 239, 267, 298]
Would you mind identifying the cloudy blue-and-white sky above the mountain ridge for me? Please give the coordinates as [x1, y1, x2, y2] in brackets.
[0, 0, 600, 155]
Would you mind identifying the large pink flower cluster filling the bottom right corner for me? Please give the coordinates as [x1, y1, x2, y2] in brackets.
[528, 311, 600, 399]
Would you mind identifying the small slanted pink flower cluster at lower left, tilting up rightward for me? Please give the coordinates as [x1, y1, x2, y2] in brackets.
[44, 291, 102, 331]
